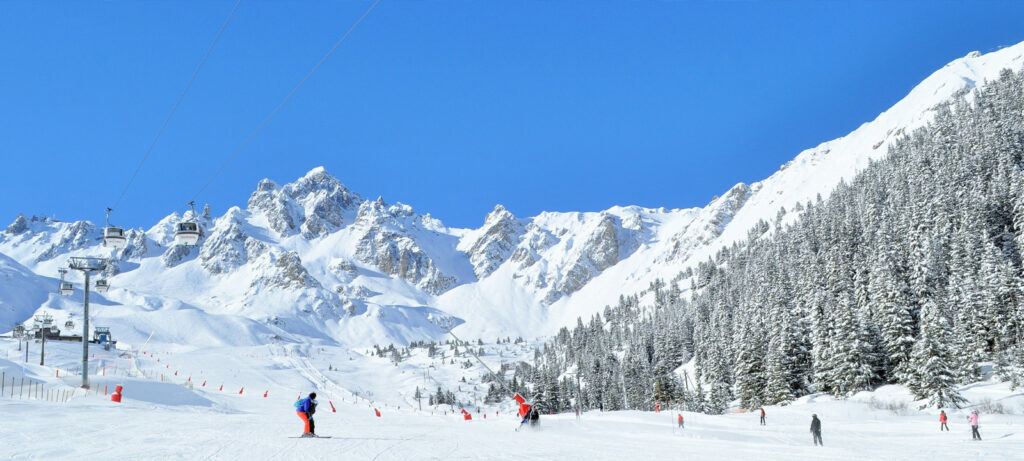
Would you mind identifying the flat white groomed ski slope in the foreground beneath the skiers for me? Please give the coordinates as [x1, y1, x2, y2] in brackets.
[0, 339, 1024, 460]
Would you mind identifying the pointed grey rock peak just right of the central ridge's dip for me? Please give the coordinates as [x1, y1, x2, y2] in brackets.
[467, 205, 525, 279]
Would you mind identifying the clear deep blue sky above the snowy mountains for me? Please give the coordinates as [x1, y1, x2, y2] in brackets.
[0, 0, 1024, 227]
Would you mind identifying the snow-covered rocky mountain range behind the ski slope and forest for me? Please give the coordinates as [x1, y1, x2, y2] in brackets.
[6, 44, 1024, 344]
